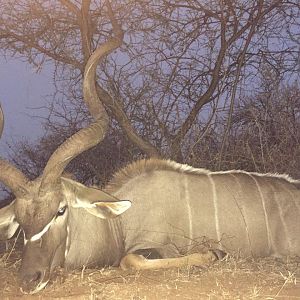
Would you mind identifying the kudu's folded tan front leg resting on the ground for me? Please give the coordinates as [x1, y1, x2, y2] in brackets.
[120, 251, 218, 270]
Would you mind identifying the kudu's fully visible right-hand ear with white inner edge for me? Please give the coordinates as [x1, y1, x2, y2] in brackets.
[62, 177, 131, 219]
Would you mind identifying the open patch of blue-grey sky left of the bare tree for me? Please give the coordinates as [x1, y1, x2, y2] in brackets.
[0, 57, 53, 155]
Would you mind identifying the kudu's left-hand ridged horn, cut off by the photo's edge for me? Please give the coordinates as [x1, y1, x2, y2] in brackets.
[0, 105, 28, 197]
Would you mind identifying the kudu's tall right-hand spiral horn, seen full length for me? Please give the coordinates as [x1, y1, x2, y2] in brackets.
[40, 12, 123, 192]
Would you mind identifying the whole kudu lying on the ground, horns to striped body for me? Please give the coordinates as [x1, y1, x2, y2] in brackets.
[0, 17, 300, 293]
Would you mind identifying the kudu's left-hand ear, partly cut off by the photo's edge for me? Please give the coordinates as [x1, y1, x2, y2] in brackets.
[0, 202, 19, 241]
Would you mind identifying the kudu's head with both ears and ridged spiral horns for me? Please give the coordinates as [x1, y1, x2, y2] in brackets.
[0, 7, 131, 293]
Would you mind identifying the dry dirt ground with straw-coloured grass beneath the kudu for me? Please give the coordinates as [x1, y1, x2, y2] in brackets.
[0, 245, 300, 300]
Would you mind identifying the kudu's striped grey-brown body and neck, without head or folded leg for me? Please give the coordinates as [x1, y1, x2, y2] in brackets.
[60, 159, 300, 269]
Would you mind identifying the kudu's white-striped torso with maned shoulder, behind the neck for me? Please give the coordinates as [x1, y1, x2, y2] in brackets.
[105, 160, 300, 256]
